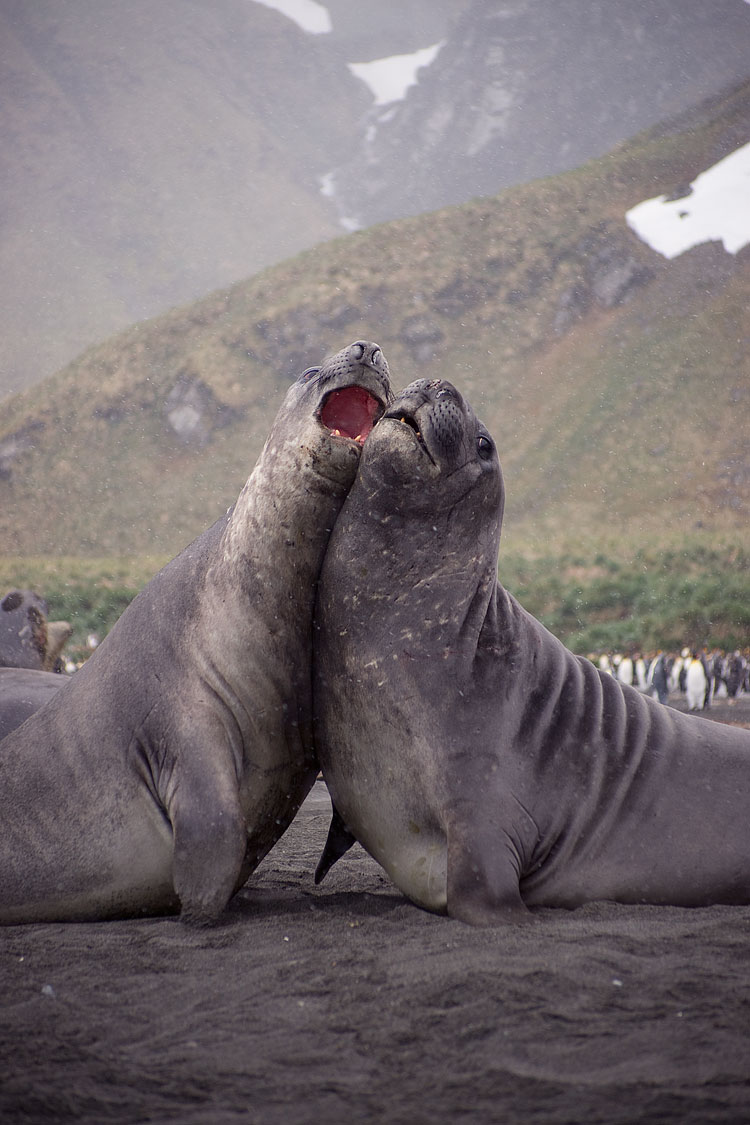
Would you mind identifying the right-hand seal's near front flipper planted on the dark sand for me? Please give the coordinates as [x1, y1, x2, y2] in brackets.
[446, 809, 532, 926]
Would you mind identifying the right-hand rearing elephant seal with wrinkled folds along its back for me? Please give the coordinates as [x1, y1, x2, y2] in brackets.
[314, 379, 750, 925]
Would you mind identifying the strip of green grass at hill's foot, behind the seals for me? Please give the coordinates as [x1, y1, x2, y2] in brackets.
[5, 537, 750, 659]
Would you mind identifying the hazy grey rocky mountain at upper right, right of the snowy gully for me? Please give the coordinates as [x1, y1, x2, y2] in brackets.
[335, 0, 750, 226]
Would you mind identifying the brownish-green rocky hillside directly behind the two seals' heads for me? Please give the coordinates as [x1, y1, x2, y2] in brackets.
[0, 77, 750, 555]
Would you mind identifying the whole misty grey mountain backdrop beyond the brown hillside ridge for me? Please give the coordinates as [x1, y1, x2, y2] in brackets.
[0, 0, 750, 398]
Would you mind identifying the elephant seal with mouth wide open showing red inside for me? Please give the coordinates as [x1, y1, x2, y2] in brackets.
[0, 342, 390, 923]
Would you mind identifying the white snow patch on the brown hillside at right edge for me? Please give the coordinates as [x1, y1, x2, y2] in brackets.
[625, 144, 750, 258]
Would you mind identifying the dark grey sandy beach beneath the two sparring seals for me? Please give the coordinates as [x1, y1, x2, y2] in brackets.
[0, 701, 750, 1125]
